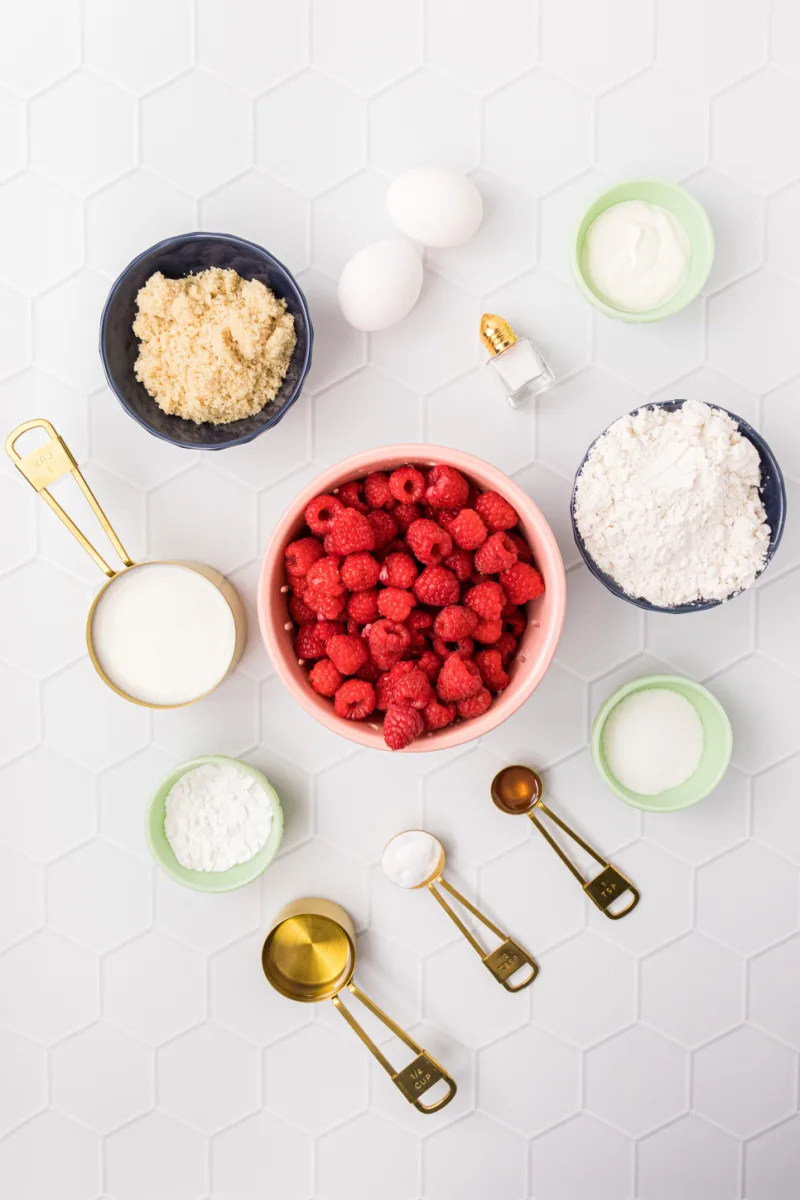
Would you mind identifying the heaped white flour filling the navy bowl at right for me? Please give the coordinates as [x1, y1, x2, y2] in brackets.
[575, 401, 770, 607]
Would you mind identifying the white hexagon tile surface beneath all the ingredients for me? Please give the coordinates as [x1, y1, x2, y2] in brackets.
[0, 0, 800, 1200]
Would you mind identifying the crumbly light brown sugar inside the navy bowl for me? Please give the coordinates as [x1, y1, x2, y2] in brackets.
[133, 266, 296, 425]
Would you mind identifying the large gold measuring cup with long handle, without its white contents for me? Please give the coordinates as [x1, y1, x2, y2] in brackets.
[6, 416, 247, 708]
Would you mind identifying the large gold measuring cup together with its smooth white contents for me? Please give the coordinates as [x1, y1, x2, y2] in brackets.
[6, 418, 246, 708]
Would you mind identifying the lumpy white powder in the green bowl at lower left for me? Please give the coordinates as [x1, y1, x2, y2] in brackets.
[164, 763, 272, 871]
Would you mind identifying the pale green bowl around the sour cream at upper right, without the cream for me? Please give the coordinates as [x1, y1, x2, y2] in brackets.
[570, 179, 714, 324]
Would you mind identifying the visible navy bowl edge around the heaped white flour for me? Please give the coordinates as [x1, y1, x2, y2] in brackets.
[570, 400, 786, 613]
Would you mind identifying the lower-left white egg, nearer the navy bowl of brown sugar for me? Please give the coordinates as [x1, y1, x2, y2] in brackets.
[339, 238, 422, 331]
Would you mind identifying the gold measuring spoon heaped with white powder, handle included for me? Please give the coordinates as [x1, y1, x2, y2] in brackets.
[383, 829, 539, 991]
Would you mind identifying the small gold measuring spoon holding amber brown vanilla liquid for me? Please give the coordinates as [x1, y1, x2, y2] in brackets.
[492, 766, 639, 920]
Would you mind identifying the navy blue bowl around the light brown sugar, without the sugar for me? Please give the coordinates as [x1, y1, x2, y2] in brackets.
[100, 233, 314, 450]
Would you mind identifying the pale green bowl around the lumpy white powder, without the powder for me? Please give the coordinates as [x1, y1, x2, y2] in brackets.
[145, 754, 283, 892]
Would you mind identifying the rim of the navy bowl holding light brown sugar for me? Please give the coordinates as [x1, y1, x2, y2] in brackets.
[100, 229, 314, 450]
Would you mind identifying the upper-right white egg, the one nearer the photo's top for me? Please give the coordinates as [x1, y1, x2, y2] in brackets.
[386, 167, 483, 247]
